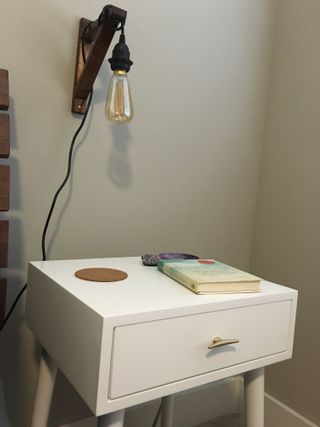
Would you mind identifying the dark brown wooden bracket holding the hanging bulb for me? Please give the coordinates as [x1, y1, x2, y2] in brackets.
[71, 5, 127, 114]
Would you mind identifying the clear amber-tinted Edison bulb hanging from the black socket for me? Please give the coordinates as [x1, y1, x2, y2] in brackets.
[106, 70, 133, 123]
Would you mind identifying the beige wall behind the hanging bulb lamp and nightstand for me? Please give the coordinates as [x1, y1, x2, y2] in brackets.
[0, 0, 274, 427]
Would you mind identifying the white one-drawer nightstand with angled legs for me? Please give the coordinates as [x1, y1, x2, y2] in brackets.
[26, 257, 297, 427]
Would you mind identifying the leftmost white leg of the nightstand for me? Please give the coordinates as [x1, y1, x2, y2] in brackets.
[31, 351, 57, 427]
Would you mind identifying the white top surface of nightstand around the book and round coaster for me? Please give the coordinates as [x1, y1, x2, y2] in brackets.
[29, 257, 296, 318]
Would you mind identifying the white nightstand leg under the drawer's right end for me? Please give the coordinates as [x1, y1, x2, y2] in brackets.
[244, 368, 264, 427]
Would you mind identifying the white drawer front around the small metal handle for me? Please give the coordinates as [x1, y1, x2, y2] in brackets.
[108, 301, 291, 399]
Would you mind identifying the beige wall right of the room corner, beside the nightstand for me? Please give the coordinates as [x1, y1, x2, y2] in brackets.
[252, 0, 320, 425]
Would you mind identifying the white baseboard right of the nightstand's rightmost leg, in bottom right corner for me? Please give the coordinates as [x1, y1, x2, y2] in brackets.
[265, 393, 319, 427]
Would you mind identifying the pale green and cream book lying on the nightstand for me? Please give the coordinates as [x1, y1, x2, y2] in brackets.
[158, 259, 261, 294]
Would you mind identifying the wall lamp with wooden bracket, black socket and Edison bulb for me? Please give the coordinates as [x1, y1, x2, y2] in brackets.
[72, 5, 133, 123]
